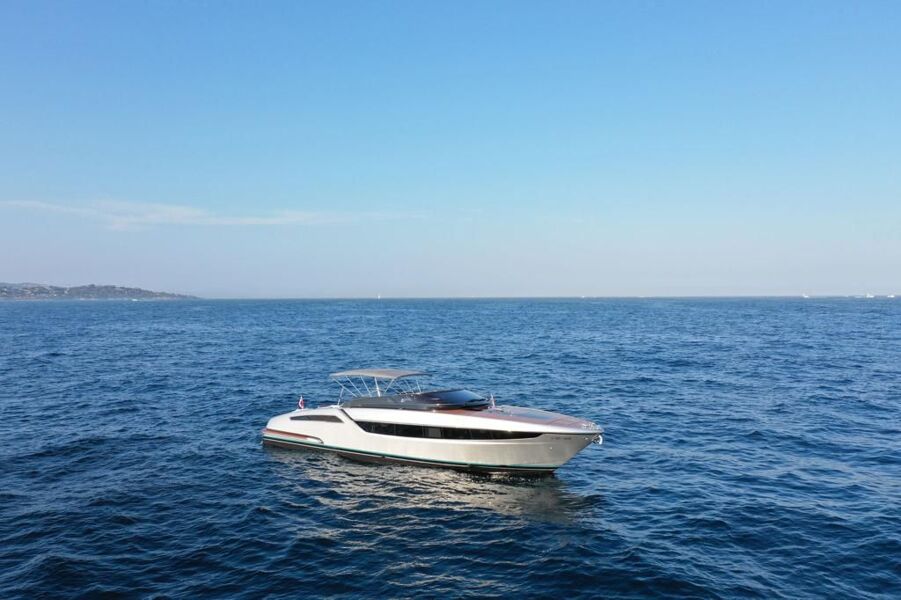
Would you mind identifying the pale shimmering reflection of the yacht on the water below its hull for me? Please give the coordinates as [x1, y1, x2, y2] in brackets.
[265, 446, 601, 523]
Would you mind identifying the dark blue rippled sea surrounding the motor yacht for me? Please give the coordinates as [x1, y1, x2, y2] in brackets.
[0, 298, 901, 599]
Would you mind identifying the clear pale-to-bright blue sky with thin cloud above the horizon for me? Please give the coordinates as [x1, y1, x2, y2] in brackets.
[0, 0, 901, 298]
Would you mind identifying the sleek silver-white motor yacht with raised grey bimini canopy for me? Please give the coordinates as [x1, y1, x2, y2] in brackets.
[263, 369, 603, 474]
